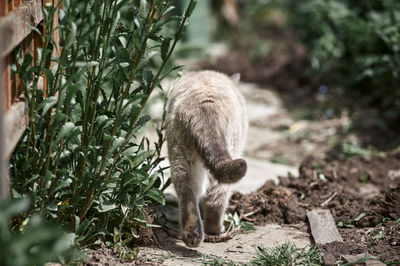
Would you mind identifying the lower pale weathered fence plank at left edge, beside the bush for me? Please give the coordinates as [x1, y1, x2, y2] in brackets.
[3, 101, 28, 158]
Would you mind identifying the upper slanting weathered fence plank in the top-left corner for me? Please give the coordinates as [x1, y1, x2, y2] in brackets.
[0, 0, 43, 57]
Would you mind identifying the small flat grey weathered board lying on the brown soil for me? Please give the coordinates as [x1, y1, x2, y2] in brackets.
[307, 209, 343, 244]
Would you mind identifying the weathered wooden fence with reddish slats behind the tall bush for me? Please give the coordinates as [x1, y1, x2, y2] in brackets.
[0, 0, 59, 194]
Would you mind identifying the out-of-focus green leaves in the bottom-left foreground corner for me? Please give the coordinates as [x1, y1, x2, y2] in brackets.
[0, 198, 75, 266]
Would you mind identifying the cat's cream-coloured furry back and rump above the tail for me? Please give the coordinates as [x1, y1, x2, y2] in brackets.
[166, 71, 248, 156]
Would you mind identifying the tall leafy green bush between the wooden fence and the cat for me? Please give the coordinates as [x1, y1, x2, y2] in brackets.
[10, 0, 196, 247]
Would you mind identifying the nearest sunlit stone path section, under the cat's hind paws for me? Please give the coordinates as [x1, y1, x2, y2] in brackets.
[139, 224, 310, 266]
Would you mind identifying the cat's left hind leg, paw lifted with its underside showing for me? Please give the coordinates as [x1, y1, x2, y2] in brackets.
[171, 150, 206, 247]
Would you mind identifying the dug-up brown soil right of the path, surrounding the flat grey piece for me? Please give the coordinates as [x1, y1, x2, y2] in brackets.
[229, 154, 400, 264]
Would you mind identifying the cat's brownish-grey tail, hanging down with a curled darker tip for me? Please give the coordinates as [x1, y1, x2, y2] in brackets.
[183, 105, 247, 184]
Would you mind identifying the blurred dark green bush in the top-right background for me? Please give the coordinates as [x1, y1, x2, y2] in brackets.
[282, 0, 400, 120]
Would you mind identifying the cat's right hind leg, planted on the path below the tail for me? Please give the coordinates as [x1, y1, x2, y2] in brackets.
[202, 179, 230, 235]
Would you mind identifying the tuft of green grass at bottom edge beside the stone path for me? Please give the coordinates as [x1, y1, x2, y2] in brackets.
[250, 242, 323, 265]
